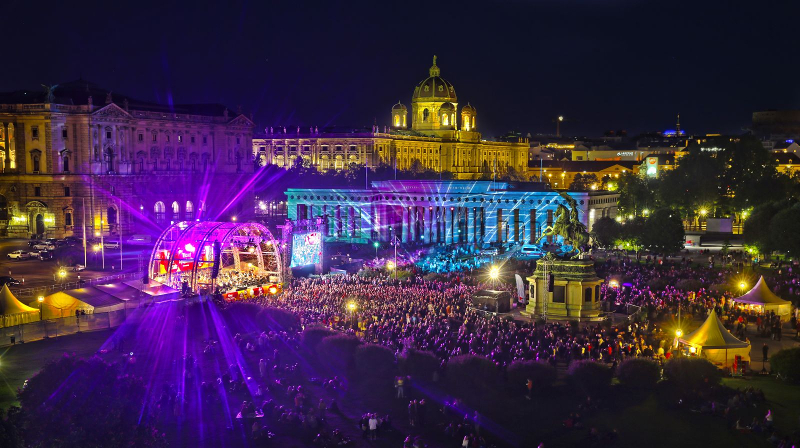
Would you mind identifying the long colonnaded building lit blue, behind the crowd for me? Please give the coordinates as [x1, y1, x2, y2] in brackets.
[286, 180, 619, 245]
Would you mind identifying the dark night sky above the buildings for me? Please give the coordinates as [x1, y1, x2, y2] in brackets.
[6, 0, 800, 137]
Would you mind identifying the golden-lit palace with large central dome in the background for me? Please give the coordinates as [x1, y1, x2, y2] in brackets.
[253, 56, 529, 179]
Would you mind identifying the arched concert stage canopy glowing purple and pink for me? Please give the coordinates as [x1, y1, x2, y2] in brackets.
[148, 221, 283, 291]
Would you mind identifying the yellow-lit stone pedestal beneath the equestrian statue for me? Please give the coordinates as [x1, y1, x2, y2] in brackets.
[522, 259, 603, 321]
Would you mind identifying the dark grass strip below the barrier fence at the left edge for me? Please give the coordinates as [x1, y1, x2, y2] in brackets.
[0, 330, 114, 409]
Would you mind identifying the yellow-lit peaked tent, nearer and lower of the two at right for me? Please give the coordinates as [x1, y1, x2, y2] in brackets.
[678, 310, 750, 367]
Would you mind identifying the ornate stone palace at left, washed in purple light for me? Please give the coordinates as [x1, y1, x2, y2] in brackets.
[0, 80, 253, 238]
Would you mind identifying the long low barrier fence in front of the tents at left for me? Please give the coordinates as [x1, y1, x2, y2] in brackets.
[0, 304, 131, 347]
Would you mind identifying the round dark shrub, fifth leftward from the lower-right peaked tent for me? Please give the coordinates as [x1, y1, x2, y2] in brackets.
[447, 355, 498, 398]
